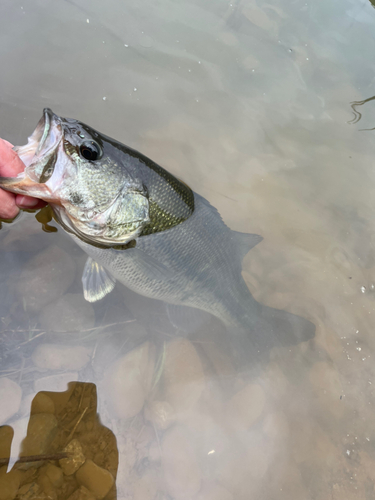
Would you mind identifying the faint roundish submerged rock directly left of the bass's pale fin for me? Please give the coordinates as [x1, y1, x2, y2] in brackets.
[16, 245, 76, 312]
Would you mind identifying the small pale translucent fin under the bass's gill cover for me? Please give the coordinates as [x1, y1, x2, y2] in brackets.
[82, 257, 116, 302]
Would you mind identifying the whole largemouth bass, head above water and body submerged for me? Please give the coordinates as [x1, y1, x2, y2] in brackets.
[0, 109, 315, 356]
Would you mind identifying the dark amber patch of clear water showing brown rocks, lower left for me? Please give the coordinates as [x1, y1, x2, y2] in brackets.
[0, 379, 118, 500]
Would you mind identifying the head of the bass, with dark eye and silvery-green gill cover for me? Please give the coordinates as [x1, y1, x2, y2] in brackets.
[0, 108, 150, 246]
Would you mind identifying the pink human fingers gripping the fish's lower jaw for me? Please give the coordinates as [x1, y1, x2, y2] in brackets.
[0, 139, 46, 219]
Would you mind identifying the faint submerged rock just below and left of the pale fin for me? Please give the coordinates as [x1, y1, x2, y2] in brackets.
[39, 293, 95, 332]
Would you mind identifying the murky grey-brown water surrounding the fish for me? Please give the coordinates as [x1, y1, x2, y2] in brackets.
[0, 0, 375, 500]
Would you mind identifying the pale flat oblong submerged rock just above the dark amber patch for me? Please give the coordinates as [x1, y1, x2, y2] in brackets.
[32, 344, 92, 370]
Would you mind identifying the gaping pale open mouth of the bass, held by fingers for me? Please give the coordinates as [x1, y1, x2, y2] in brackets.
[0, 108, 63, 201]
